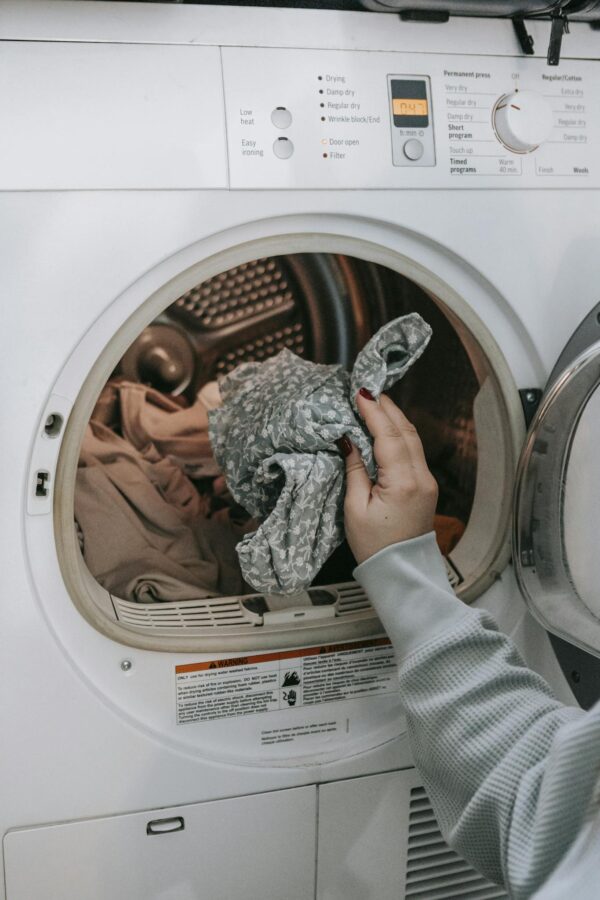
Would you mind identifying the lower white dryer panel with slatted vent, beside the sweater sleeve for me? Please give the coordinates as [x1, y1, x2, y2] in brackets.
[317, 769, 507, 900]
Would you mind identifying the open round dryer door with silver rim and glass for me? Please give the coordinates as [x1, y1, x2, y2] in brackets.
[513, 310, 600, 657]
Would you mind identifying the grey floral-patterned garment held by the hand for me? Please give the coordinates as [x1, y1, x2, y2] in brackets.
[209, 313, 431, 594]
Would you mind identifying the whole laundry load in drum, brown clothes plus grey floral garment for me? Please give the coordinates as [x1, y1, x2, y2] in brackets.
[75, 313, 460, 603]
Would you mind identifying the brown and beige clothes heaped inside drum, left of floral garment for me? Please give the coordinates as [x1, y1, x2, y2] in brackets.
[75, 381, 251, 603]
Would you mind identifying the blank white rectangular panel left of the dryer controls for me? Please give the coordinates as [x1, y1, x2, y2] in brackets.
[0, 41, 227, 190]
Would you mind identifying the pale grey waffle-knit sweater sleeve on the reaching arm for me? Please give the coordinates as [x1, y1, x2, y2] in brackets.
[355, 533, 600, 900]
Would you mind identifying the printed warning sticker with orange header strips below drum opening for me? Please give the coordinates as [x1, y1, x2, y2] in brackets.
[175, 638, 398, 725]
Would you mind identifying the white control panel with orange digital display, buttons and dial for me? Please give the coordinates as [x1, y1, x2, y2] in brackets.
[222, 47, 600, 190]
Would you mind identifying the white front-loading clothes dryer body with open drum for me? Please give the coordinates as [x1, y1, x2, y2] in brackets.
[0, 0, 600, 900]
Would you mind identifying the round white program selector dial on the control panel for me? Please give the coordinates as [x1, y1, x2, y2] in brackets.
[492, 91, 554, 153]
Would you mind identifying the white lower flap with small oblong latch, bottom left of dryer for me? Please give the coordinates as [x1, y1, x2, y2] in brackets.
[4, 786, 316, 900]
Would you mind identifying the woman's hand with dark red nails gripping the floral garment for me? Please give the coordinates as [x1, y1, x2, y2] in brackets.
[338, 389, 438, 563]
